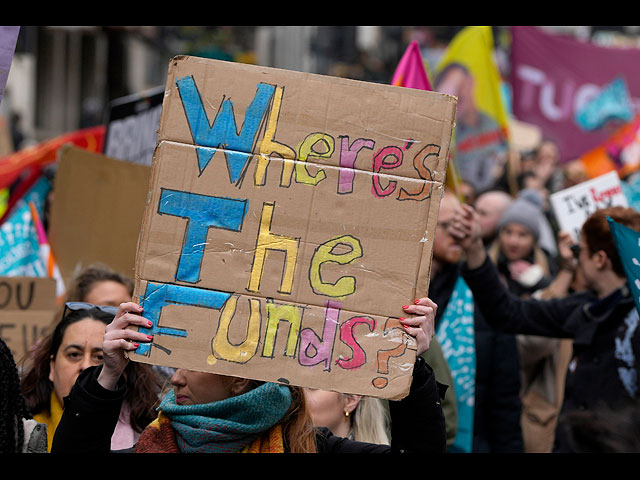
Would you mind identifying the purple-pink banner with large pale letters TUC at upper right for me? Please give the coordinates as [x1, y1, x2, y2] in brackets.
[511, 26, 640, 161]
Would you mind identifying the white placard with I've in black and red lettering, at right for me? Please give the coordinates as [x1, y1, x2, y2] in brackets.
[549, 171, 628, 242]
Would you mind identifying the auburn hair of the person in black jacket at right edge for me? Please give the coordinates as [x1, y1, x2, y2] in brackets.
[582, 207, 640, 277]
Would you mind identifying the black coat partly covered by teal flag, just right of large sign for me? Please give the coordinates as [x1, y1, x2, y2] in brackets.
[429, 263, 524, 453]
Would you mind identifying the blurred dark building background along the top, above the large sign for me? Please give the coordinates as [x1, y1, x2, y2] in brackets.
[0, 26, 640, 152]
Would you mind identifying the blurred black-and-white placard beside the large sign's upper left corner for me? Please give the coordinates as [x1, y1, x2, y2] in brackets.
[104, 87, 164, 165]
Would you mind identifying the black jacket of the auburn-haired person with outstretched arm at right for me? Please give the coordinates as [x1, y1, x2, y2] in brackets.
[463, 259, 640, 452]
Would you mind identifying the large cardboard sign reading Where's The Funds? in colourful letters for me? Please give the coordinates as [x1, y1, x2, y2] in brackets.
[131, 56, 456, 399]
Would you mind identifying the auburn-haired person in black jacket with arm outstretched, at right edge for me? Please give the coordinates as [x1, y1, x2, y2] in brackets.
[450, 205, 640, 452]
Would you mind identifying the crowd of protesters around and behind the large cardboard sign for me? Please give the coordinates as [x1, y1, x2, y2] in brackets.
[0, 124, 640, 453]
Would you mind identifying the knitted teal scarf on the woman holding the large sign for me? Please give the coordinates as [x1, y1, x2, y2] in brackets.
[158, 383, 292, 453]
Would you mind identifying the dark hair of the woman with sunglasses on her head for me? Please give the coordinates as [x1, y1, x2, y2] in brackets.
[22, 308, 113, 414]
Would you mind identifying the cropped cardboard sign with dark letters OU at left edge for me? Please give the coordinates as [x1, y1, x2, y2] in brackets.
[0, 277, 58, 362]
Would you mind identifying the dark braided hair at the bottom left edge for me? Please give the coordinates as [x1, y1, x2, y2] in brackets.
[0, 338, 32, 453]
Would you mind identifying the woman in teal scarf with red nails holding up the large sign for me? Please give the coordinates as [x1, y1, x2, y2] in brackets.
[52, 298, 446, 453]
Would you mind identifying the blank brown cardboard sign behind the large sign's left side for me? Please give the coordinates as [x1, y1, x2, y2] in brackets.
[49, 145, 151, 284]
